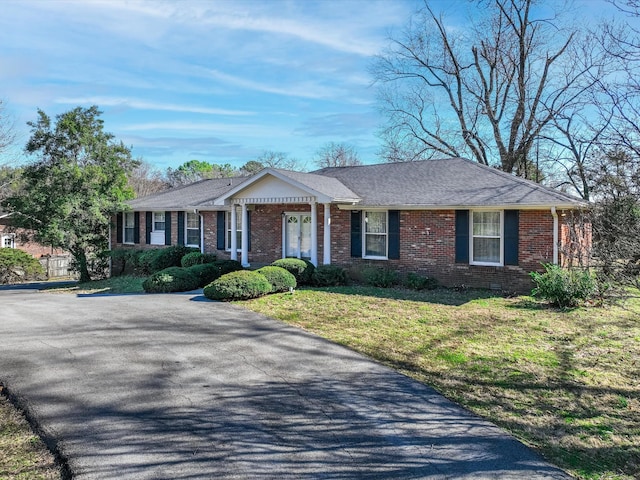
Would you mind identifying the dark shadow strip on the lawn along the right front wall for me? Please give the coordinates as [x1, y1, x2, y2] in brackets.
[305, 285, 504, 306]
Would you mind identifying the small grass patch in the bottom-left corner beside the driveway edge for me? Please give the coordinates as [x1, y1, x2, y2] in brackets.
[0, 386, 61, 480]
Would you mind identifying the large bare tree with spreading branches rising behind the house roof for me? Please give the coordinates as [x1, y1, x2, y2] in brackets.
[373, 0, 595, 175]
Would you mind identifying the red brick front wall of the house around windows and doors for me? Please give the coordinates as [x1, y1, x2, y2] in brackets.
[113, 204, 584, 291]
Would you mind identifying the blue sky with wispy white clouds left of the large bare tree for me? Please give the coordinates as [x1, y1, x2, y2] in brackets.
[0, 0, 624, 170]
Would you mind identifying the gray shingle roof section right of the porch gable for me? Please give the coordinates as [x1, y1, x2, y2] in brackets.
[313, 158, 581, 207]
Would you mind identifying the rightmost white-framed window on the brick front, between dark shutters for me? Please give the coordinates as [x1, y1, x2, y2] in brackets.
[470, 211, 503, 265]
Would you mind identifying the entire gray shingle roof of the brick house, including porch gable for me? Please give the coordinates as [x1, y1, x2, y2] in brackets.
[124, 158, 585, 211]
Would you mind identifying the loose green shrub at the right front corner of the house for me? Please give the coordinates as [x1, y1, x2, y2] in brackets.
[530, 264, 597, 308]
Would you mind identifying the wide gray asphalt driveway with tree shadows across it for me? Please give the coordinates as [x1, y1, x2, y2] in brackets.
[0, 290, 567, 479]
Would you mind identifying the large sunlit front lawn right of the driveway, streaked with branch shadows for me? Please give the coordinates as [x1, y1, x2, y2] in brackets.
[241, 287, 640, 480]
